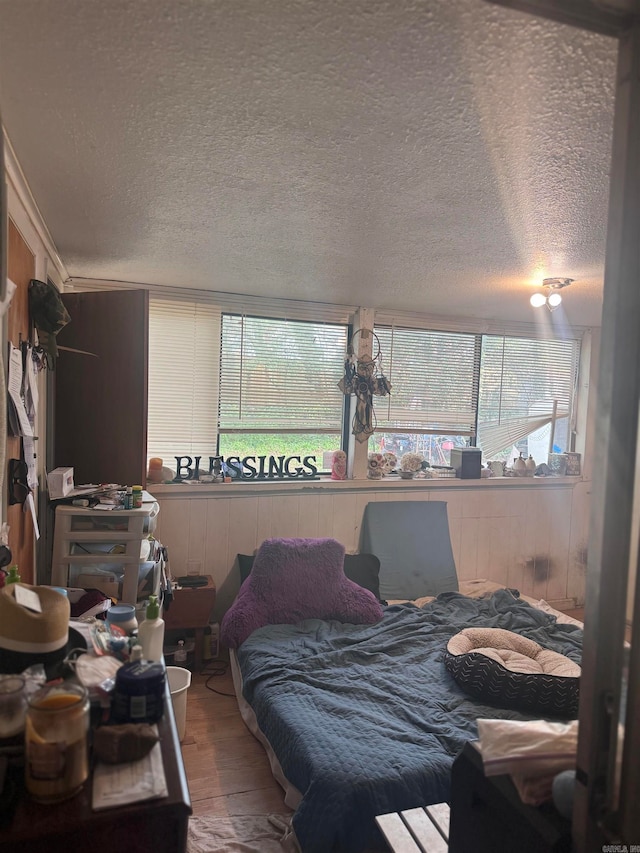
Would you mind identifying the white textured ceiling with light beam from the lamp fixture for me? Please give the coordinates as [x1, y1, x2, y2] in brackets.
[0, 0, 617, 325]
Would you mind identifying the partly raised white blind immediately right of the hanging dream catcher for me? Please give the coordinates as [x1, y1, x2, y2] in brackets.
[374, 326, 480, 436]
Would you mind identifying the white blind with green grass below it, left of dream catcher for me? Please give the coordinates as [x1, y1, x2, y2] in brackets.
[220, 314, 347, 433]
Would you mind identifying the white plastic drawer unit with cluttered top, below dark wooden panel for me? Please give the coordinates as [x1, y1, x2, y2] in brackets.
[51, 493, 160, 604]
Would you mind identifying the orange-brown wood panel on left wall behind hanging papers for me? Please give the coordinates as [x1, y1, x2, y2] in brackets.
[4, 219, 38, 583]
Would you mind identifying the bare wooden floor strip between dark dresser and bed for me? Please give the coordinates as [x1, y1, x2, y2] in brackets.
[182, 660, 291, 817]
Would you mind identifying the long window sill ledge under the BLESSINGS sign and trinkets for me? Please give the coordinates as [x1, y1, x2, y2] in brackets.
[147, 477, 584, 500]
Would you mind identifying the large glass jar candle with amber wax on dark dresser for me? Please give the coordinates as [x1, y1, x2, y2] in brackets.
[25, 681, 89, 803]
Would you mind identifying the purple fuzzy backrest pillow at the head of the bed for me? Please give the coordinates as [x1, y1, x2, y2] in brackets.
[220, 539, 382, 649]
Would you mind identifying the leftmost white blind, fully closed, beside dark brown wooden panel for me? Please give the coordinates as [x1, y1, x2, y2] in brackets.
[147, 296, 220, 467]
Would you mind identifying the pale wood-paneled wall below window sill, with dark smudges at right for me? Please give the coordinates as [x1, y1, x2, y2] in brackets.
[156, 480, 590, 618]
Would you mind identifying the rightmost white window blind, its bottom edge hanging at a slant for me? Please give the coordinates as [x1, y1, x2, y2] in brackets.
[478, 335, 580, 459]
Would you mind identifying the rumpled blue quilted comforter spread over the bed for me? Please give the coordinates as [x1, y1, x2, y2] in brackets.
[238, 590, 582, 853]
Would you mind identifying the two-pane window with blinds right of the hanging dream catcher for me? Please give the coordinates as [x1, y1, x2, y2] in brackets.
[369, 326, 580, 465]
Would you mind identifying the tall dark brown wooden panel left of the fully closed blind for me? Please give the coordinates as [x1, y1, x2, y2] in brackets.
[53, 290, 149, 486]
